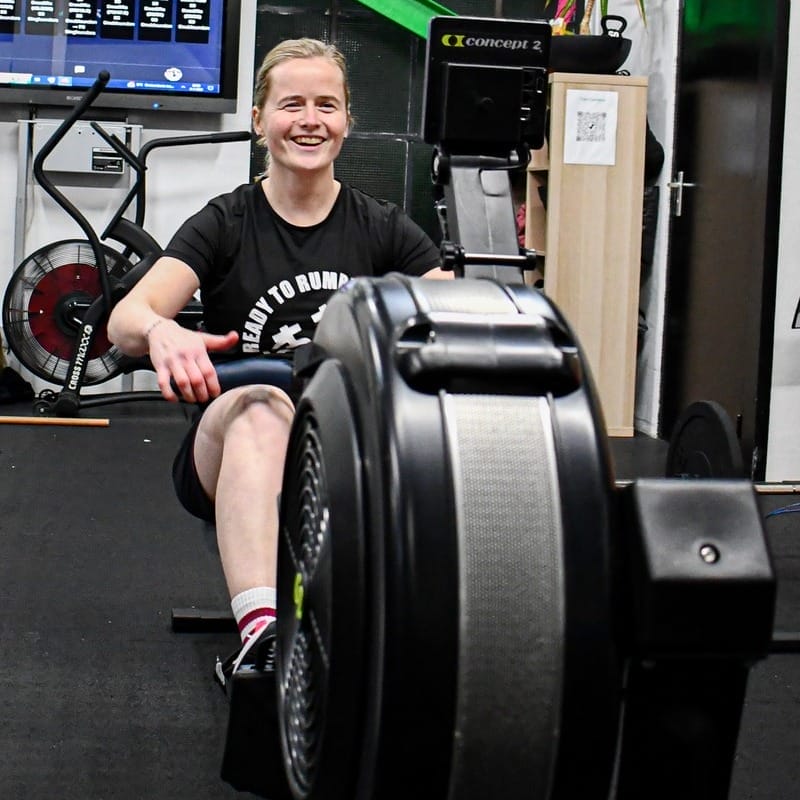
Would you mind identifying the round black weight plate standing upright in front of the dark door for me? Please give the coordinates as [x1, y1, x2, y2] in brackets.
[665, 400, 745, 478]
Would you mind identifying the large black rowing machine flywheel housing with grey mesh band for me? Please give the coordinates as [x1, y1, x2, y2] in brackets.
[277, 275, 622, 800]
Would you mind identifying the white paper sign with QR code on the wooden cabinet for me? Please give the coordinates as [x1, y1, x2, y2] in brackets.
[564, 89, 619, 167]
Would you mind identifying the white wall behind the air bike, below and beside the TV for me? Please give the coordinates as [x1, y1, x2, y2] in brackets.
[0, 0, 256, 391]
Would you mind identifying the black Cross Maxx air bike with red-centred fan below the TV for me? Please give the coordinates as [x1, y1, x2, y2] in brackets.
[2, 71, 291, 417]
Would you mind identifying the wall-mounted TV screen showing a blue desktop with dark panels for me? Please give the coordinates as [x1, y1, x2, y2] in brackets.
[0, 0, 240, 113]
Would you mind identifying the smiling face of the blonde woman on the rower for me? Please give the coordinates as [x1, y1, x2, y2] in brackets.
[253, 57, 347, 179]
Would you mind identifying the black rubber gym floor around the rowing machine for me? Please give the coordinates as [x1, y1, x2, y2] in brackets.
[0, 403, 800, 800]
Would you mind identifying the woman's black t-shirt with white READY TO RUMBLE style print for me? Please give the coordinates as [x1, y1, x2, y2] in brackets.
[164, 184, 440, 354]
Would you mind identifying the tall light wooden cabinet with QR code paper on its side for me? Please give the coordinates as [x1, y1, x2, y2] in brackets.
[526, 73, 647, 436]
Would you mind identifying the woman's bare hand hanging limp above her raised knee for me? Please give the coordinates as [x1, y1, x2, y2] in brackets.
[147, 319, 239, 403]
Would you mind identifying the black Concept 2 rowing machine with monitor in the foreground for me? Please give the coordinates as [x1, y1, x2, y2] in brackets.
[214, 17, 788, 800]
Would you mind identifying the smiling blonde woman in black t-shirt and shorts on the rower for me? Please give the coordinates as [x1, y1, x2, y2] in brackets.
[108, 39, 449, 669]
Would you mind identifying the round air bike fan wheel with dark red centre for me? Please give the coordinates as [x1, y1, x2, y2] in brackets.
[3, 239, 131, 386]
